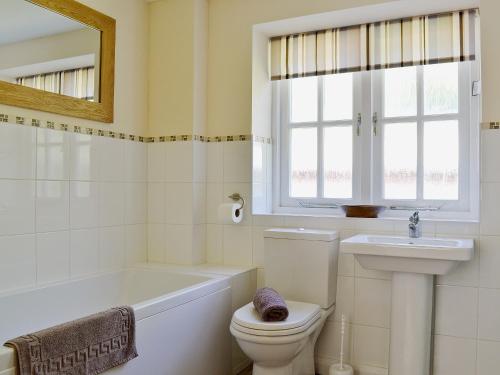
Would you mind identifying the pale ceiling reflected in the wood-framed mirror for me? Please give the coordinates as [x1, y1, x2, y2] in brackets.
[0, 0, 86, 45]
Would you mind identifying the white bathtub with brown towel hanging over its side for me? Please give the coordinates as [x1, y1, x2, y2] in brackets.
[0, 266, 231, 375]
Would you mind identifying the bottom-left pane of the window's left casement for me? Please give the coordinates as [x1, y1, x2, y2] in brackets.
[290, 128, 318, 198]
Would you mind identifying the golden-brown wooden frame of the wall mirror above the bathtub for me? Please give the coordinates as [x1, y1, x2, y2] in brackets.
[0, 0, 116, 123]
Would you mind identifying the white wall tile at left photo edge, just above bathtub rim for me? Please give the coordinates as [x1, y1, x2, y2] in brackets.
[0, 234, 36, 291]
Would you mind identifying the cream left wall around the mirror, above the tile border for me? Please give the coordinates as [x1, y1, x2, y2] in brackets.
[0, 0, 148, 135]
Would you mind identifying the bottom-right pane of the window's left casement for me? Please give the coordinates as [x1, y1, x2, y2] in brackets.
[323, 126, 352, 198]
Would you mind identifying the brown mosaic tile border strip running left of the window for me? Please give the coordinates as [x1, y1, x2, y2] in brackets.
[0, 113, 272, 144]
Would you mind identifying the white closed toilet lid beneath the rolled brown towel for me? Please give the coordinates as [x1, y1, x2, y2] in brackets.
[233, 301, 320, 331]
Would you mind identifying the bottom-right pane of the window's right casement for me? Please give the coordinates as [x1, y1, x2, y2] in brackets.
[424, 120, 459, 200]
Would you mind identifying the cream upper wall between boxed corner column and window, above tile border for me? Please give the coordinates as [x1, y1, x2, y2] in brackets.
[208, 0, 385, 136]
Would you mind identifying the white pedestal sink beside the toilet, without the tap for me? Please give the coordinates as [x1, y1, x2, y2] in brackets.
[340, 234, 474, 375]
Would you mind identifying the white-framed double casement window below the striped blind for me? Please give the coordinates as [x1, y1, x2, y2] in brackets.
[274, 62, 479, 217]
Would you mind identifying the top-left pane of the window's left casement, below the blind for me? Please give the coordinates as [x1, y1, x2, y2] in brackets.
[290, 77, 318, 122]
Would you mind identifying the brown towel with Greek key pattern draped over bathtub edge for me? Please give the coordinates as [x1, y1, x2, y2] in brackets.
[5, 306, 137, 375]
